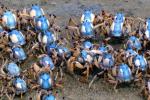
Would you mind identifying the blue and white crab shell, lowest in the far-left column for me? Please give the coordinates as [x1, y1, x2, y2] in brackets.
[13, 77, 27, 94]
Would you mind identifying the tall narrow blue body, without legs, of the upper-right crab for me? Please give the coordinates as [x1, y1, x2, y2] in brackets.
[111, 13, 125, 37]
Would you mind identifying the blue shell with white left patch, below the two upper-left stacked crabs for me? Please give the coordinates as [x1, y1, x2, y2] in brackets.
[38, 31, 56, 44]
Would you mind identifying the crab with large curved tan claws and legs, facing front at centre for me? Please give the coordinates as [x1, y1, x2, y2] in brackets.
[67, 42, 93, 81]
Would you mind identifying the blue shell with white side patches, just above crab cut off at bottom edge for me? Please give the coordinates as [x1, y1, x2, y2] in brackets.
[39, 72, 52, 90]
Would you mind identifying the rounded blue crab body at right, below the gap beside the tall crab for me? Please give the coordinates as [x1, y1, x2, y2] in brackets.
[126, 36, 142, 50]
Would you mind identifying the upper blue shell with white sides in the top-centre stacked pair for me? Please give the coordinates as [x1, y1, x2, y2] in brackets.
[81, 10, 95, 23]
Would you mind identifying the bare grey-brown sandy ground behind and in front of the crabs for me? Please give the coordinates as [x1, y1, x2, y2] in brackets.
[0, 0, 150, 100]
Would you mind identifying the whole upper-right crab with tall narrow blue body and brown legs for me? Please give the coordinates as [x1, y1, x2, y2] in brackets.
[104, 12, 132, 40]
